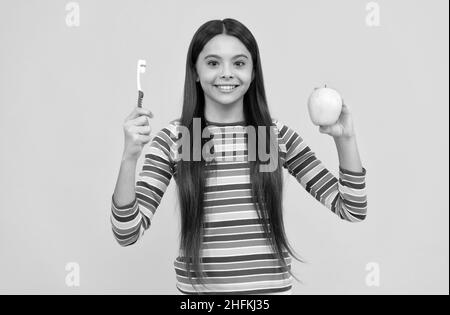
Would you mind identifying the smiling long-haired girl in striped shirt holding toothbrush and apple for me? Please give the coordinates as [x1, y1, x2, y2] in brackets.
[111, 19, 367, 294]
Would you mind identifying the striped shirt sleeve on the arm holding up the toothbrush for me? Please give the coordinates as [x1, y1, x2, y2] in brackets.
[110, 121, 178, 246]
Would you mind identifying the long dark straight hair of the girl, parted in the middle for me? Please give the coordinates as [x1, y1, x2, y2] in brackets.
[176, 18, 301, 283]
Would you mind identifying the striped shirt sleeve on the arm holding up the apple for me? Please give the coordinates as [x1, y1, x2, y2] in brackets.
[275, 121, 367, 222]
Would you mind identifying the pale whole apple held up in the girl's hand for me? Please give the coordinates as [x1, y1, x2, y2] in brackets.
[308, 85, 342, 126]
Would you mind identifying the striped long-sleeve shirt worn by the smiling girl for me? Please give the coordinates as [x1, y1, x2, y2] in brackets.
[111, 120, 367, 294]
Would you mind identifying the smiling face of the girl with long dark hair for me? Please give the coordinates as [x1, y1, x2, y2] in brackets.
[195, 34, 254, 105]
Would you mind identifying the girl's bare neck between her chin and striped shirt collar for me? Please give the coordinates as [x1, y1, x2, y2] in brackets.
[205, 99, 245, 123]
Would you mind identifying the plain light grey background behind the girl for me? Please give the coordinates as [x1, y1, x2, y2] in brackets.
[0, 0, 449, 294]
